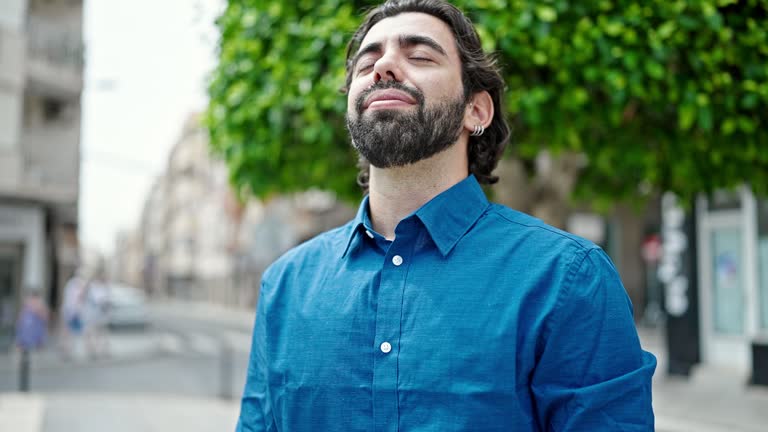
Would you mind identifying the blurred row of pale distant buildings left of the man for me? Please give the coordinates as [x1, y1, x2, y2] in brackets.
[118, 115, 355, 306]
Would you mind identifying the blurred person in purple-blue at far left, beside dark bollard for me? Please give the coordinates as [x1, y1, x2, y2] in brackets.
[16, 289, 49, 392]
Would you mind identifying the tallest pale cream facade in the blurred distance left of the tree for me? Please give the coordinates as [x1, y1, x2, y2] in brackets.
[163, 116, 242, 301]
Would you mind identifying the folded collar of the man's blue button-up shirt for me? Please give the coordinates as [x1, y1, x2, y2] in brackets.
[342, 175, 489, 258]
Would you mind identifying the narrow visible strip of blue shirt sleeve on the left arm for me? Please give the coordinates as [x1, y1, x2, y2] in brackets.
[236, 280, 276, 432]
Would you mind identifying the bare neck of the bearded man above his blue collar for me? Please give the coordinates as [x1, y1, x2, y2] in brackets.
[368, 142, 469, 240]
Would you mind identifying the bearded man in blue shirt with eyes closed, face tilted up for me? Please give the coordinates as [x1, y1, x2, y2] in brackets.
[238, 0, 655, 432]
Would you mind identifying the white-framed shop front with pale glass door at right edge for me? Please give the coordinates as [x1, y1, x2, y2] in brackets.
[696, 188, 768, 371]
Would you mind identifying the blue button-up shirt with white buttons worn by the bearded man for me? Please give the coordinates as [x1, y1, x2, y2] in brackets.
[237, 176, 656, 432]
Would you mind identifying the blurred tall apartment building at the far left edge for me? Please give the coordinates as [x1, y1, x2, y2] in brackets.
[0, 0, 83, 348]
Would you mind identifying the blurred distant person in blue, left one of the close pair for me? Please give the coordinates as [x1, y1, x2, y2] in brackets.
[59, 269, 87, 359]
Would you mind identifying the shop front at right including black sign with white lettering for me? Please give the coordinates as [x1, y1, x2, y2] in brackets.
[659, 187, 768, 375]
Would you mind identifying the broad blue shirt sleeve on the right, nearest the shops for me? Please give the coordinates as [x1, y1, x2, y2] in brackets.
[531, 249, 656, 431]
